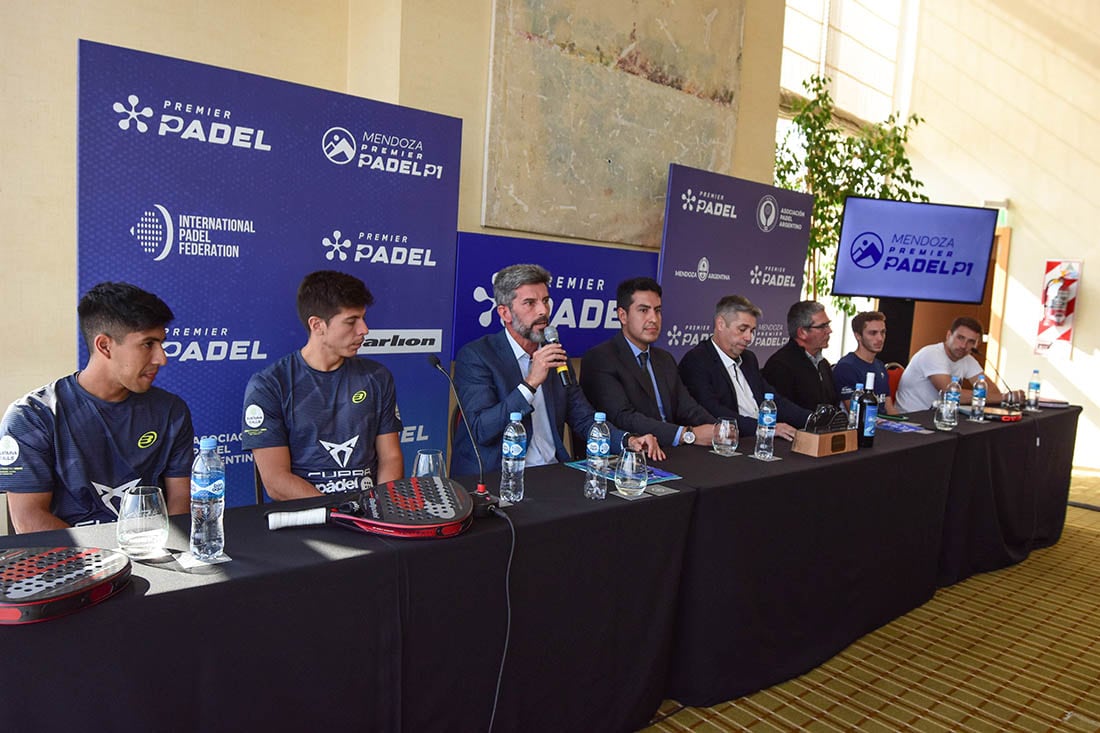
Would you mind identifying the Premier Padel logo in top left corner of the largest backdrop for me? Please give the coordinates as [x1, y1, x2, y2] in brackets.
[111, 94, 272, 153]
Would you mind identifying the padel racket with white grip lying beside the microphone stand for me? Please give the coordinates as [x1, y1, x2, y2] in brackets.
[267, 477, 474, 539]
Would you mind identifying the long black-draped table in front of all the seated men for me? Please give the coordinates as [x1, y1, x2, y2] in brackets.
[0, 408, 1080, 731]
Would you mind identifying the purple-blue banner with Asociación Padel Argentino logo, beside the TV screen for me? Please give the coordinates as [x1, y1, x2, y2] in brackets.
[658, 165, 813, 364]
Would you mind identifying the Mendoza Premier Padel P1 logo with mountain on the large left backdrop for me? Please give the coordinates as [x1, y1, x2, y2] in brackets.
[321, 127, 443, 180]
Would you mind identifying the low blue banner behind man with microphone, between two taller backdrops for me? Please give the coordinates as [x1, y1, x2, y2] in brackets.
[452, 232, 657, 358]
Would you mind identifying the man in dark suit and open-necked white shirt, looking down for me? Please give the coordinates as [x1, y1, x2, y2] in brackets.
[680, 295, 810, 440]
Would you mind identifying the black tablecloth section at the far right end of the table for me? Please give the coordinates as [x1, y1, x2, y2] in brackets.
[927, 407, 1081, 586]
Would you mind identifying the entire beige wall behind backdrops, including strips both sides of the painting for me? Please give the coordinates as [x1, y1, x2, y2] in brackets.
[0, 0, 783, 404]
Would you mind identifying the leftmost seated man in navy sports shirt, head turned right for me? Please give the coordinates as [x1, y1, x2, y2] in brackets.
[0, 283, 195, 533]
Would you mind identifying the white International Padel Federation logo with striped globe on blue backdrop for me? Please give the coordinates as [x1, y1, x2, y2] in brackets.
[130, 204, 256, 262]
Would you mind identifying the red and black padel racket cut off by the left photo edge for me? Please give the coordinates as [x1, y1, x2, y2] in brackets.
[0, 547, 130, 624]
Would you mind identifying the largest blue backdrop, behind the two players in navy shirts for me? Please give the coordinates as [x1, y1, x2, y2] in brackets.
[77, 41, 462, 504]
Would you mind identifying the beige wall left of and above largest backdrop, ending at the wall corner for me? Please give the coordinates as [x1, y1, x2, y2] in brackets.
[0, 0, 348, 405]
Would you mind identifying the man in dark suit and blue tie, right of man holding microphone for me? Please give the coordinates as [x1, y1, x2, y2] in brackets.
[581, 277, 714, 446]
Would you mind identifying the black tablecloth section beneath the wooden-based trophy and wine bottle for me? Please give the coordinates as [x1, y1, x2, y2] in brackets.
[666, 424, 957, 705]
